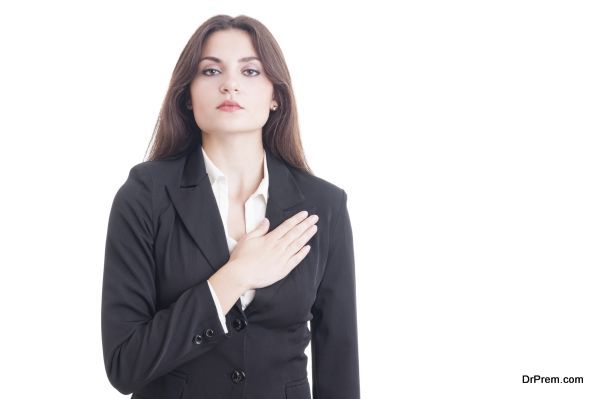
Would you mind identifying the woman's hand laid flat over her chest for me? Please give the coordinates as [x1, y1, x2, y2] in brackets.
[229, 211, 319, 289]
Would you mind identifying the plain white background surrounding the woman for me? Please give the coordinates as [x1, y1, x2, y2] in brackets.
[0, 0, 600, 399]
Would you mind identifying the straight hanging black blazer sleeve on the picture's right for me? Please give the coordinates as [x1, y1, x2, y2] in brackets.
[310, 190, 360, 399]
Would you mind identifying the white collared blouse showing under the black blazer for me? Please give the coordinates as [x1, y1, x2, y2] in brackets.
[202, 148, 269, 332]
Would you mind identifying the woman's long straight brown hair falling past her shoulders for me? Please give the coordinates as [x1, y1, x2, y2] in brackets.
[148, 15, 313, 174]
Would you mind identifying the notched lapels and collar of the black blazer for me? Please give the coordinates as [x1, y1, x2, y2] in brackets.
[167, 141, 304, 312]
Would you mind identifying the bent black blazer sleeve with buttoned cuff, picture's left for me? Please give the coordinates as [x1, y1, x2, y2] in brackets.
[101, 165, 226, 395]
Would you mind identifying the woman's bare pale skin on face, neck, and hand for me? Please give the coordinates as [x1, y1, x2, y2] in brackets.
[188, 29, 318, 314]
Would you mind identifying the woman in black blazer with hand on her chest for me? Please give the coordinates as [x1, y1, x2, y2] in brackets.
[102, 15, 360, 399]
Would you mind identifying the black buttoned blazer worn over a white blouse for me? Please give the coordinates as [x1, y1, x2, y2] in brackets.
[101, 142, 360, 399]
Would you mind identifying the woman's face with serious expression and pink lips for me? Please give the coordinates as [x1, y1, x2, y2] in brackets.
[190, 29, 275, 138]
